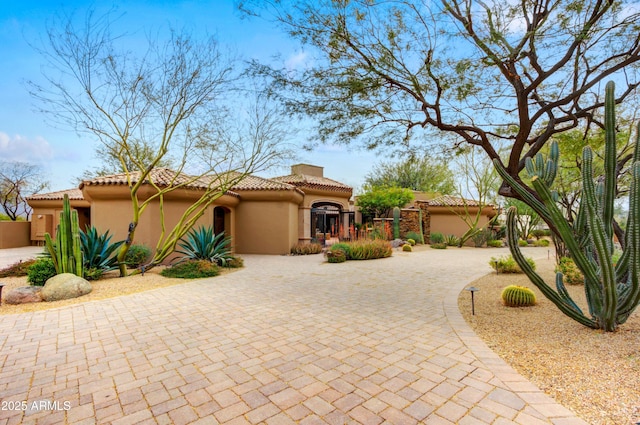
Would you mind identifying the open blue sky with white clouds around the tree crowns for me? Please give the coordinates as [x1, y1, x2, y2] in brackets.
[0, 0, 376, 191]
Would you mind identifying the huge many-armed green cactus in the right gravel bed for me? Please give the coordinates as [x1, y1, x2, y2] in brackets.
[494, 82, 640, 331]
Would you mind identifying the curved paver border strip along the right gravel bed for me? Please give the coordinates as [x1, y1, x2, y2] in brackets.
[442, 273, 589, 425]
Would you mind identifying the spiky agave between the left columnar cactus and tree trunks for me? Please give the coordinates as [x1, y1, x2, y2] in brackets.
[80, 226, 124, 272]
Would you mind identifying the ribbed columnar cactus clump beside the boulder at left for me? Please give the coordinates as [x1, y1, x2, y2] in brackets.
[44, 194, 83, 277]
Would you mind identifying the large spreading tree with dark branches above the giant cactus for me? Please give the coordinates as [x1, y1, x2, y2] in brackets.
[240, 0, 640, 230]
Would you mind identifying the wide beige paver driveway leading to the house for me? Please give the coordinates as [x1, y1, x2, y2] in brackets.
[0, 249, 585, 425]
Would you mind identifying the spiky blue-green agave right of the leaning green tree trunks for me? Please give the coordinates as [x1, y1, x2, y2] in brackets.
[176, 226, 233, 266]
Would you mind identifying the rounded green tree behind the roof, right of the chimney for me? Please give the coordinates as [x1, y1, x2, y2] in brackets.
[365, 156, 456, 195]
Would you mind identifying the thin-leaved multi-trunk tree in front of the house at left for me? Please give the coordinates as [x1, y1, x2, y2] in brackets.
[30, 13, 288, 275]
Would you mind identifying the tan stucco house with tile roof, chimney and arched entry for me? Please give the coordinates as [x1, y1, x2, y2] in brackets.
[28, 164, 353, 254]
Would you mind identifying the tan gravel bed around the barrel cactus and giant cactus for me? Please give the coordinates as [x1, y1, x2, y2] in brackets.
[458, 259, 640, 425]
